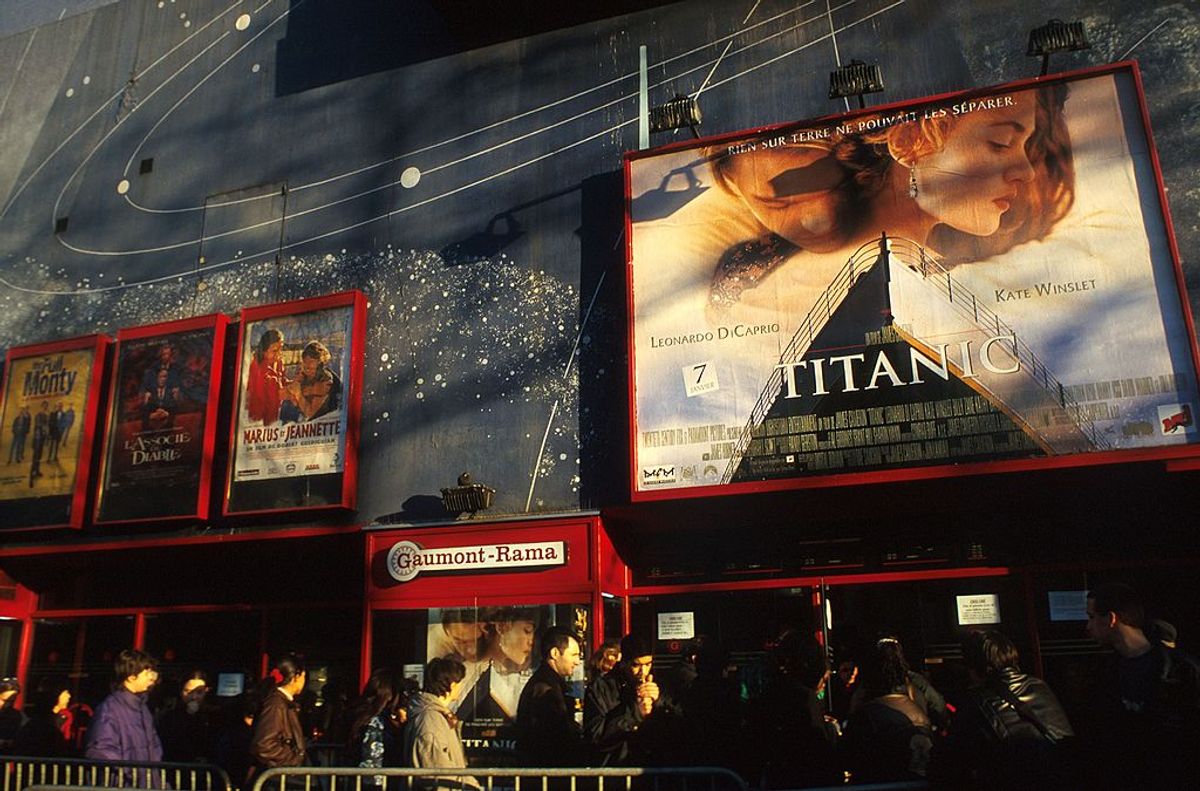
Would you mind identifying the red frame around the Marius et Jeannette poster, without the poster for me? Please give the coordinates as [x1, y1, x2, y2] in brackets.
[222, 289, 367, 517]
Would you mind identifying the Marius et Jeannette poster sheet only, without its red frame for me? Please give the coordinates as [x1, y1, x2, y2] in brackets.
[232, 306, 354, 484]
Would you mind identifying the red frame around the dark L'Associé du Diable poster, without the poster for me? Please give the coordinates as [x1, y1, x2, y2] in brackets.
[91, 313, 229, 525]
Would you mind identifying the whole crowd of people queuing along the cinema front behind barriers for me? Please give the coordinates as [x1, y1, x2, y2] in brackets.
[0, 585, 1200, 789]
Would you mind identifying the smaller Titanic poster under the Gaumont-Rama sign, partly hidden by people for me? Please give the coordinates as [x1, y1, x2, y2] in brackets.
[426, 605, 588, 766]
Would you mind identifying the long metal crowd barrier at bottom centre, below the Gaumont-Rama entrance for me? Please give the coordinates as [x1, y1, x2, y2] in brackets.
[248, 767, 749, 791]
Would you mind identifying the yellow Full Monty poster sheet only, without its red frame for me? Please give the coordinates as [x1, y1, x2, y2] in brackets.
[0, 347, 96, 501]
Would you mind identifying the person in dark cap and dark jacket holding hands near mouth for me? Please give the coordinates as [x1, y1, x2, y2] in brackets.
[583, 635, 665, 766]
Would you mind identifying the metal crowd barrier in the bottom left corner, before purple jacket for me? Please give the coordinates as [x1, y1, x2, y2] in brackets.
[0, 755, 233, 791]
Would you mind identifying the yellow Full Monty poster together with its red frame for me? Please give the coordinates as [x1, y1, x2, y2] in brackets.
[0, 335, 110, 531]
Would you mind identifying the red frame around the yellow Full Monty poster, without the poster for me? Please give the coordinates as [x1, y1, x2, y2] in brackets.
[0, 334, 112, 533]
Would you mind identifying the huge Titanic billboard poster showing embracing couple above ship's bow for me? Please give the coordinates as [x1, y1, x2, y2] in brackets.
[626, 64, 1200, 496]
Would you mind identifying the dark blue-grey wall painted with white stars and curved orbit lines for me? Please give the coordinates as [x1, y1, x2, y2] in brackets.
[0, 0, 1200, 520]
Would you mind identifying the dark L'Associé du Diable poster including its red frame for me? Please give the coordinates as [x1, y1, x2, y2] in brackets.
[96, 317, 224, 522]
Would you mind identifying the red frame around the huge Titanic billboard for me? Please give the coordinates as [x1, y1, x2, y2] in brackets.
[623, 61, 1200, 503]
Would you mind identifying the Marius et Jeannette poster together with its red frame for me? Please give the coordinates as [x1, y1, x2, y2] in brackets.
[224, 290, 366, 515]
